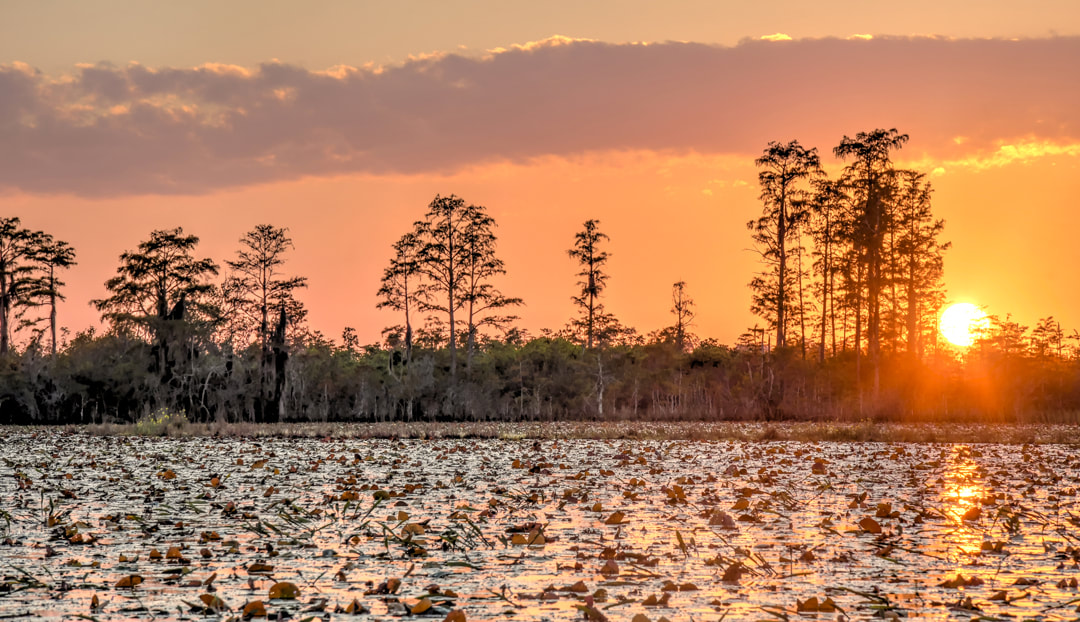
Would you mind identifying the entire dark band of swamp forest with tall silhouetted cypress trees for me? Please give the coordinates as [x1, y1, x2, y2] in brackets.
[0, 130, 1080, 423]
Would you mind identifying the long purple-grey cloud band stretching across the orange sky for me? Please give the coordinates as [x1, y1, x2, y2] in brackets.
[0, 37, 1080, 195]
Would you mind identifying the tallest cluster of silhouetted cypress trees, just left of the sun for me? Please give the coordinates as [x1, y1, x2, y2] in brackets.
[747, 129, 949, 401]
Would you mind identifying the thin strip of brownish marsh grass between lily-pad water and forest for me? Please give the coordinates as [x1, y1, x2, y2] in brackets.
[66, 415, 1080, 444]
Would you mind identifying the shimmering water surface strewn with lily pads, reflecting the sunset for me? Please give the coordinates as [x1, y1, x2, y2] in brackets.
[0, 431, 1080, 621]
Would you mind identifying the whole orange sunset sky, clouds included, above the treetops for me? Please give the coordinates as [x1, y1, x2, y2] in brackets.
[0, 0, 1080, 342]
